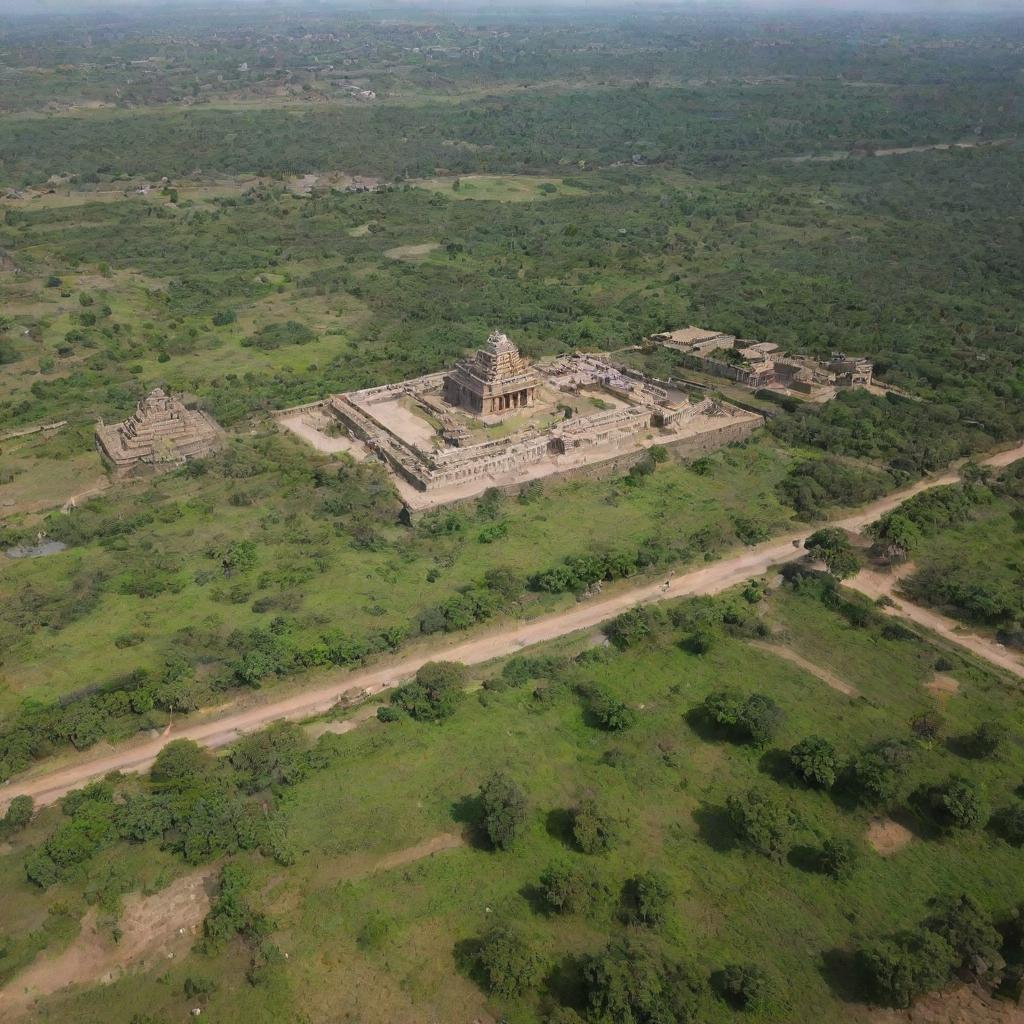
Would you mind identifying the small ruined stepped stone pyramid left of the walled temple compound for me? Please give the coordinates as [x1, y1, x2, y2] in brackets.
[96, 387, 220, 474]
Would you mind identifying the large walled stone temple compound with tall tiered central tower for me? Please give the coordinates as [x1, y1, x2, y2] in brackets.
[286, 332, 764, 512]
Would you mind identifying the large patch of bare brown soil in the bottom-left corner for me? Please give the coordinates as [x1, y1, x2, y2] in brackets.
[0, 868, 213, 1020]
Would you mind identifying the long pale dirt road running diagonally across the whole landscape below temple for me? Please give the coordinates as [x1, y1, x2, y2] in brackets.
[0, 444, 1024, 810]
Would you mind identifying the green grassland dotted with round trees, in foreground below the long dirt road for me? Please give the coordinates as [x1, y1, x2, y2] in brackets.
[0, 588, 1024, 1024]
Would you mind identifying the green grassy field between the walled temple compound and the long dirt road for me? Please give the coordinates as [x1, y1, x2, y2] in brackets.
[0, 435, 792, 711]
